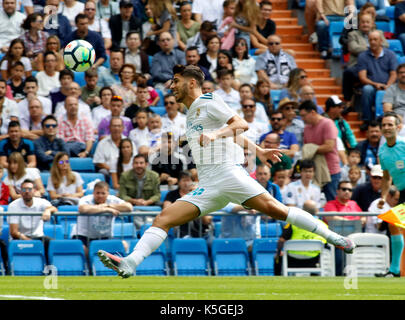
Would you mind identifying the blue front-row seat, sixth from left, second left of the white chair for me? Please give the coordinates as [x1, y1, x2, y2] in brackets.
[211, 238, 251, 276]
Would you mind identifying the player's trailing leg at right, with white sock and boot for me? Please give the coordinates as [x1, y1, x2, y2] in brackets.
[244, 193, 355, 253]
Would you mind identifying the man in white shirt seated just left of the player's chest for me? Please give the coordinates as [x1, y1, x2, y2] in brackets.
[162, 93, 186, 141]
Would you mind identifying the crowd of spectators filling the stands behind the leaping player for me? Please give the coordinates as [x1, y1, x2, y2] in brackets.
[0, 0, 405, 275]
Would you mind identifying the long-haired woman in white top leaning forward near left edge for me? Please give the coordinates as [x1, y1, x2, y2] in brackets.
[4, 152, 45, 200]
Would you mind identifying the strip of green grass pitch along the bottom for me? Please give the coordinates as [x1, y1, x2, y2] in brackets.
[0, 276, 405, 300]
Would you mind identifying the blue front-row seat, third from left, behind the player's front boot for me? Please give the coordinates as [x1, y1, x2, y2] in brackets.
[89, 239, 125, 276]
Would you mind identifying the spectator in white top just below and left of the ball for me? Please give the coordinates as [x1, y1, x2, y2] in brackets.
[35, 51, 61, 97]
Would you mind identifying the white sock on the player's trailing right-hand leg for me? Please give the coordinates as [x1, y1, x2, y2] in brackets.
[286, 207, 340, 242]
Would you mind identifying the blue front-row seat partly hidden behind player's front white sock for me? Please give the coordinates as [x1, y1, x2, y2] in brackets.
[129, 240, 169, 276]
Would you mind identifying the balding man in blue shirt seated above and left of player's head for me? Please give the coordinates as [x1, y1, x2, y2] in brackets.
[150, 32, 186, 93]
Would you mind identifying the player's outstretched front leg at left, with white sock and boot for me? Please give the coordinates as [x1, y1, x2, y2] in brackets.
[98, 201, 200, 278]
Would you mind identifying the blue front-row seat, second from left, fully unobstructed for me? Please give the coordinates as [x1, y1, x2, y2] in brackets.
[48, 240, 88, 276]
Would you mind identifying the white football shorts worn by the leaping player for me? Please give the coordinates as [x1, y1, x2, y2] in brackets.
[177, 165, 267, 216]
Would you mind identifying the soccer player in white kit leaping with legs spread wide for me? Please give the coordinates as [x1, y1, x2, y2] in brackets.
[98, 65, 355, 278]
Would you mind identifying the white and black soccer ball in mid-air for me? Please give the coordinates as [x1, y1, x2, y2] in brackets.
[63, 40, 96, 72]
